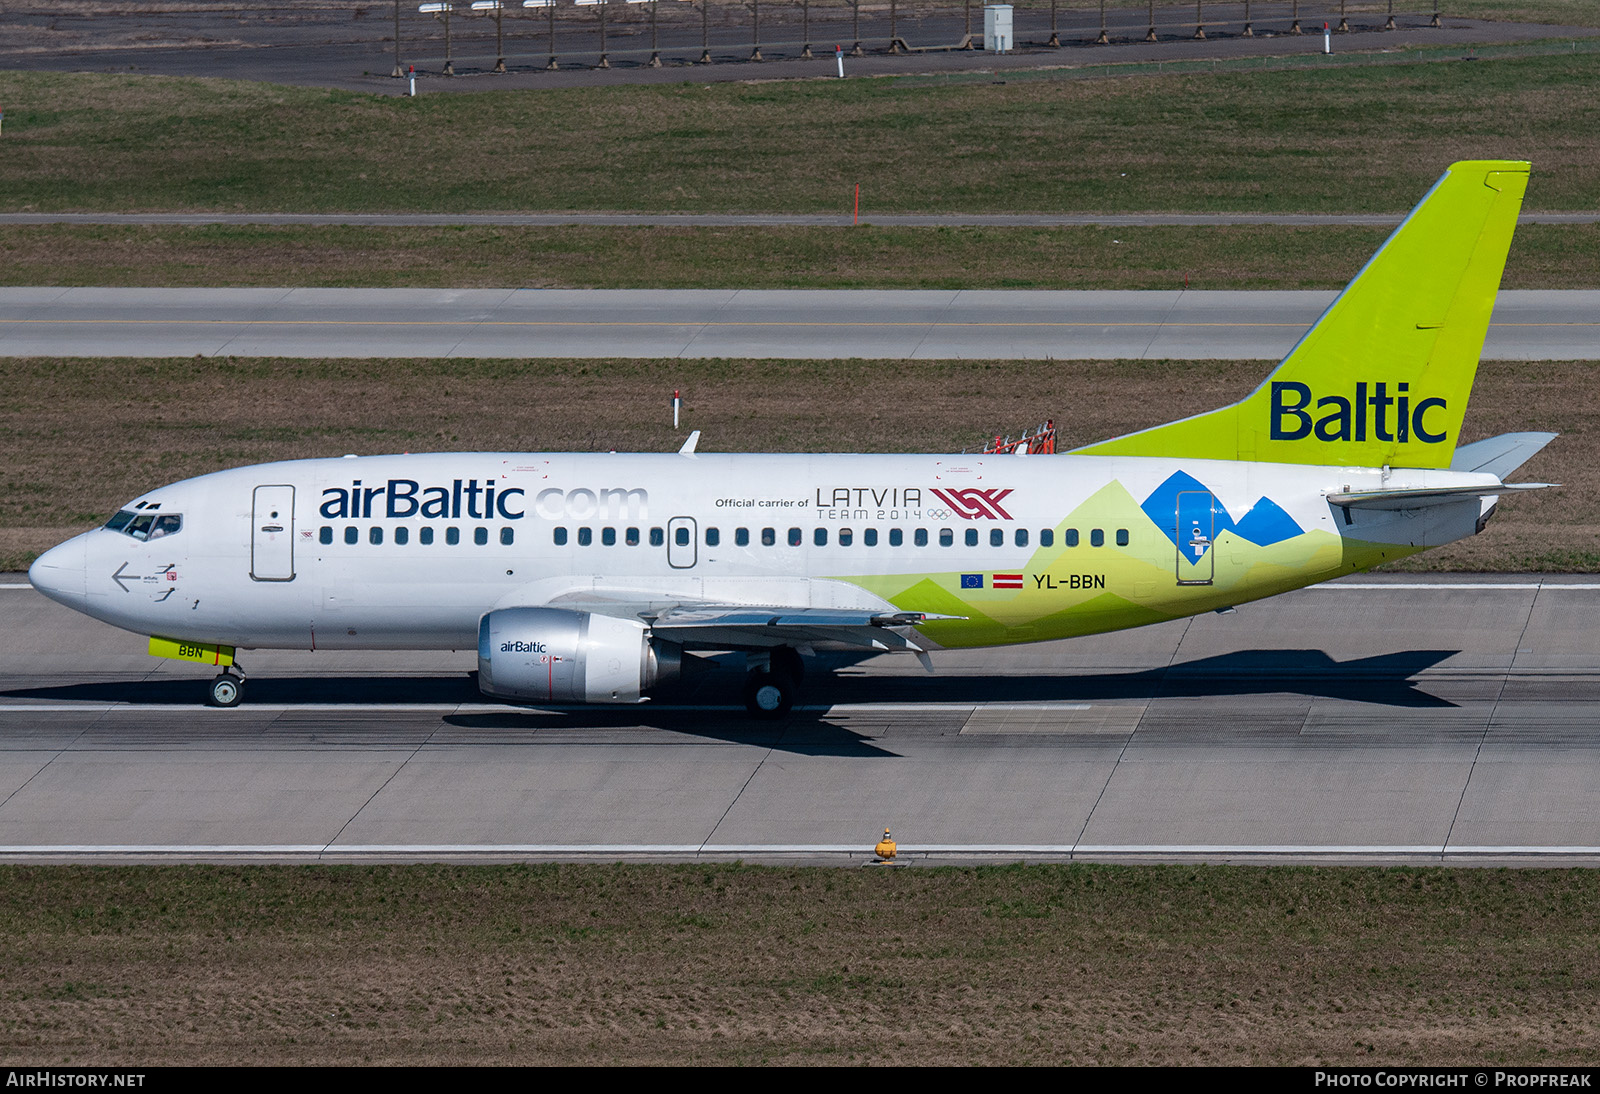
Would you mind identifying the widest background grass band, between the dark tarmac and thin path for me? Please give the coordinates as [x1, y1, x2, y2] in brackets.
[0, 53, 1600, 216]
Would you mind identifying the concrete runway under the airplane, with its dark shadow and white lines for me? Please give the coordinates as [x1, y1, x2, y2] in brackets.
[0, 576, 1600, 864]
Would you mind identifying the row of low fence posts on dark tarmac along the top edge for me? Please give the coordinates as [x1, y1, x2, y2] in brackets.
[387, 0, 1443, 77]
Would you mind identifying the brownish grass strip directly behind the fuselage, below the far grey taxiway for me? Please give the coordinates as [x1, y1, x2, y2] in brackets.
[0, 358, 1600, 571]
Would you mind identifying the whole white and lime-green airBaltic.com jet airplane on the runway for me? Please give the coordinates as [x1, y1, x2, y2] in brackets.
[29, 162, 1554, 717]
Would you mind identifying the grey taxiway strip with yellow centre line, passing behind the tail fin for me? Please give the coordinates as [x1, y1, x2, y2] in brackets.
[0, 288, 1600, 360]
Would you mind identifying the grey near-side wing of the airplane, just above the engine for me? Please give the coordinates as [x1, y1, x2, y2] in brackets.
[646, 605, 960, 651]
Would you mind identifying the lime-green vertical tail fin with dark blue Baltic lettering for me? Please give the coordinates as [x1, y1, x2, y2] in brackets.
[1075, 160, 1528, 467]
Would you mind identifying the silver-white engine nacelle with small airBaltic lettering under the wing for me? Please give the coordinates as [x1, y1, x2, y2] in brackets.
[478, 608, 682, 702]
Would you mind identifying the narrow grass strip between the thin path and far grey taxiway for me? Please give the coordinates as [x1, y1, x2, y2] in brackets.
[0, 220, 1600, 289]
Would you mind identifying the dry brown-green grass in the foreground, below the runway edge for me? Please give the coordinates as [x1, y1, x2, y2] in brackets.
[0, 865, 1600, 1065]
